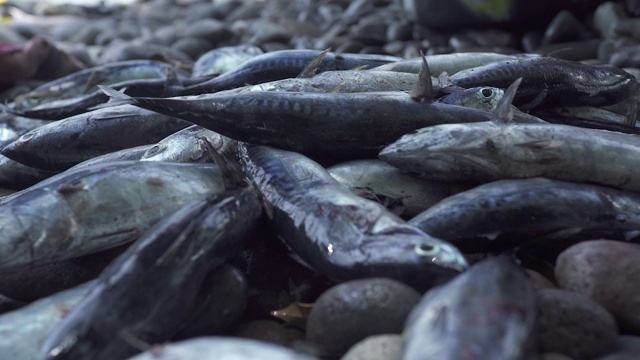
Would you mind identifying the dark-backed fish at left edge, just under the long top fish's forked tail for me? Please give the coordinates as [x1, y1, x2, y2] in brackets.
[1, 105, 190, 171]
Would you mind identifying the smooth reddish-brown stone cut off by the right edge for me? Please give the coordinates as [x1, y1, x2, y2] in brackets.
[555, 240, 640, 333]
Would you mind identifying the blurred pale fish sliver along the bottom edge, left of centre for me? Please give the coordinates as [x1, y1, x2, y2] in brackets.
[129, 336, 318, 360]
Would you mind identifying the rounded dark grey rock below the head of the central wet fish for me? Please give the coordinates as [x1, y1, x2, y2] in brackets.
[307, 278, 421, 358]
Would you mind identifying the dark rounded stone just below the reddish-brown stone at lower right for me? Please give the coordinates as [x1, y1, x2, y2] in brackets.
[536, 289, 618, 360]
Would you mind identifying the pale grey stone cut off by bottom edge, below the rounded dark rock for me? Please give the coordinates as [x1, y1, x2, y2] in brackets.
[340, 334, 403, 360]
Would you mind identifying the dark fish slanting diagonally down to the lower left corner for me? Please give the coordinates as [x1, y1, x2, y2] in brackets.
[38, 189, 262, 360]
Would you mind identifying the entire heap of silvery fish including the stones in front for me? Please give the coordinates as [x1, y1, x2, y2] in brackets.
[0, 0, 640, 360]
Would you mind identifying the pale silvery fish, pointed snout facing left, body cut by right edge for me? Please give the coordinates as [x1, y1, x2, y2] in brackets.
[380, 122, 640, 191]
